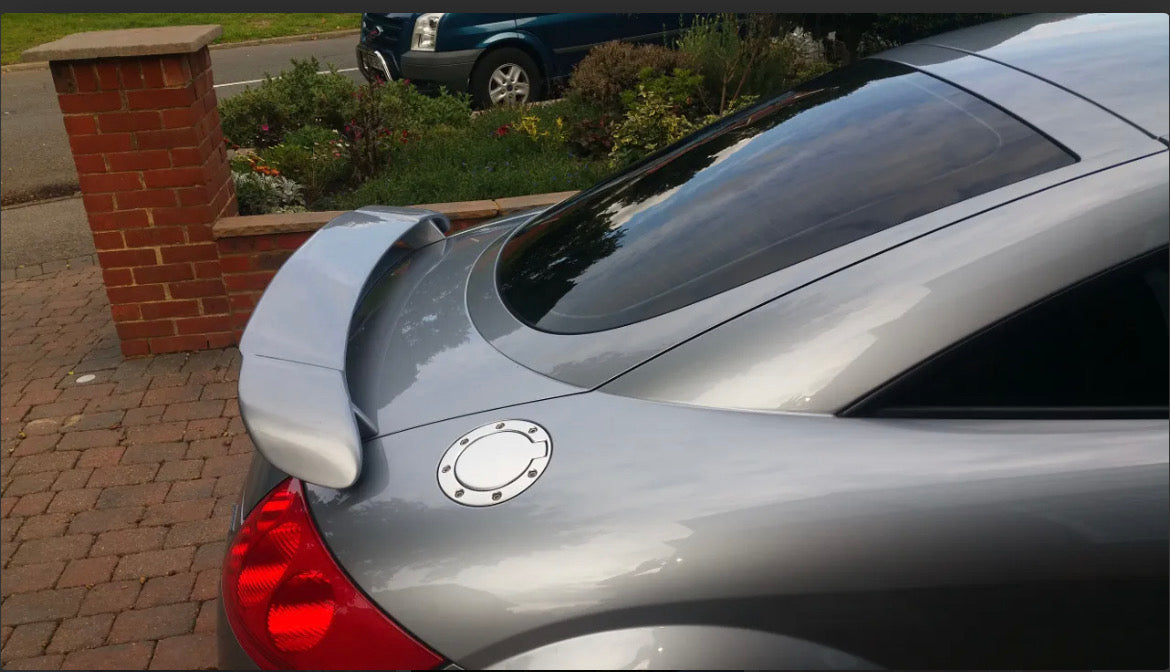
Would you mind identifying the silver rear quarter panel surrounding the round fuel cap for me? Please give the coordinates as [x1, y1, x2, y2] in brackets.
[308, 392, 1168, 667]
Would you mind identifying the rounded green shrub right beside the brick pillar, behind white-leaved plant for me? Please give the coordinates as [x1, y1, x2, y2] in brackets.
[219, 59, 357, 148]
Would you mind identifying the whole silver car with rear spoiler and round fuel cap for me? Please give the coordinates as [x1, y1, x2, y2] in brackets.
[219, 14, 1170, 668]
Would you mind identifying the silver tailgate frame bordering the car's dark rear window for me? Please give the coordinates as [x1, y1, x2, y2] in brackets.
[468, 31, 1165, 393]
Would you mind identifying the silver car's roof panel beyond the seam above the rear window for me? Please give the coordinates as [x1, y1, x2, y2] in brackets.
[920, 14, 1170, 138]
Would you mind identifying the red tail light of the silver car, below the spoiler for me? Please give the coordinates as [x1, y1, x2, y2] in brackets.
[223, 479, 442, 670]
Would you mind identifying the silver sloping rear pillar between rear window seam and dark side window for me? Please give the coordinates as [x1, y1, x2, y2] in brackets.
[603, 151, 1170, 413]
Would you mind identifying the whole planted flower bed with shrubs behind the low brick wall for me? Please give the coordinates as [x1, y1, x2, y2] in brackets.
[220, 15, 831, 214]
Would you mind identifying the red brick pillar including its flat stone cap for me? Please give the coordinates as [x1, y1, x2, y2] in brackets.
[25, 26, 236, 356]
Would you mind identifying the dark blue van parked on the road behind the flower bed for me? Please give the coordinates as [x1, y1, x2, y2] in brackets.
[357, 13, 690, 107]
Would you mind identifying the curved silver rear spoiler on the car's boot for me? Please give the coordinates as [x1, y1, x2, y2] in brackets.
[240, 206, 450, 488]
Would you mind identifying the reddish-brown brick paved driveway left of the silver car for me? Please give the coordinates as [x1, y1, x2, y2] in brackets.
[0, 266, 252, 670]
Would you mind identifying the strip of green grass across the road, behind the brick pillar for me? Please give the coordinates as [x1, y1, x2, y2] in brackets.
[0, 13, 360, 66]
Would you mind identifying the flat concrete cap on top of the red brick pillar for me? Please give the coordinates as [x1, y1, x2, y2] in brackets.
[21, 25, 223, 61]
